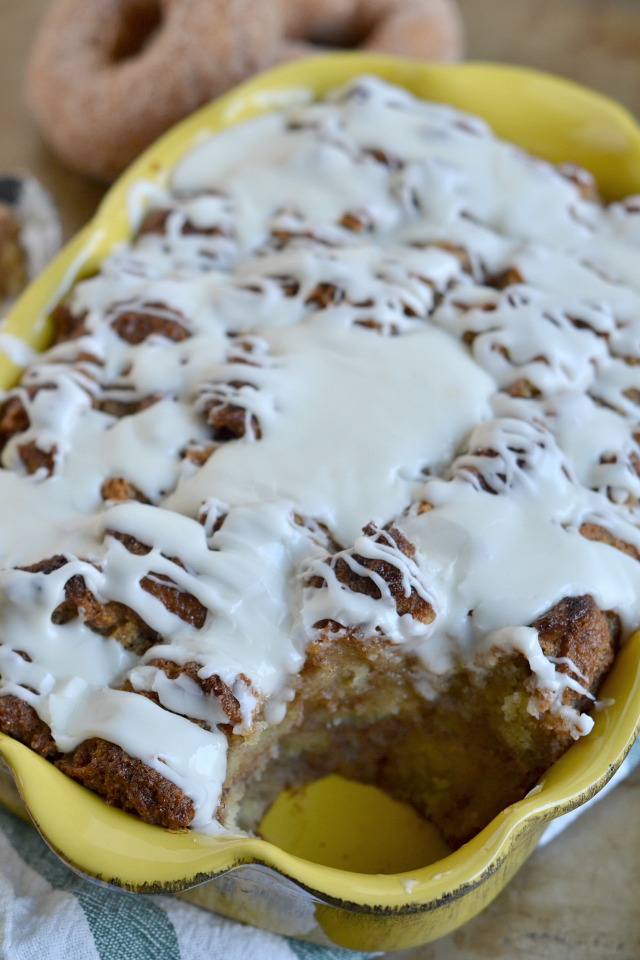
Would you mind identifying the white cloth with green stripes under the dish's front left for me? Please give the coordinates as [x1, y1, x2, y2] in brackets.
[0, 807, 373, 960]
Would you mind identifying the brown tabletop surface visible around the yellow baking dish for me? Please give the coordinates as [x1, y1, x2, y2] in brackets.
[0, 0, 640, 960]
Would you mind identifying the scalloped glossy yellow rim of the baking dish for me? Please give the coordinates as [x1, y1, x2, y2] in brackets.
[0, 53, 640, 949]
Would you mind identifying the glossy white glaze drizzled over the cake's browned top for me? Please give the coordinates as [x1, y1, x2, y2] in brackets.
[0, 78, 640, 832]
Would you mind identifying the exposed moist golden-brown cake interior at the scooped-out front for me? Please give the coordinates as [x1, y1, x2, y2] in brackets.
[224, 598, 619, 847]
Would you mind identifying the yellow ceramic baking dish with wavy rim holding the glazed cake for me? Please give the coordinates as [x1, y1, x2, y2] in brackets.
[0, 54, 640, 950]
